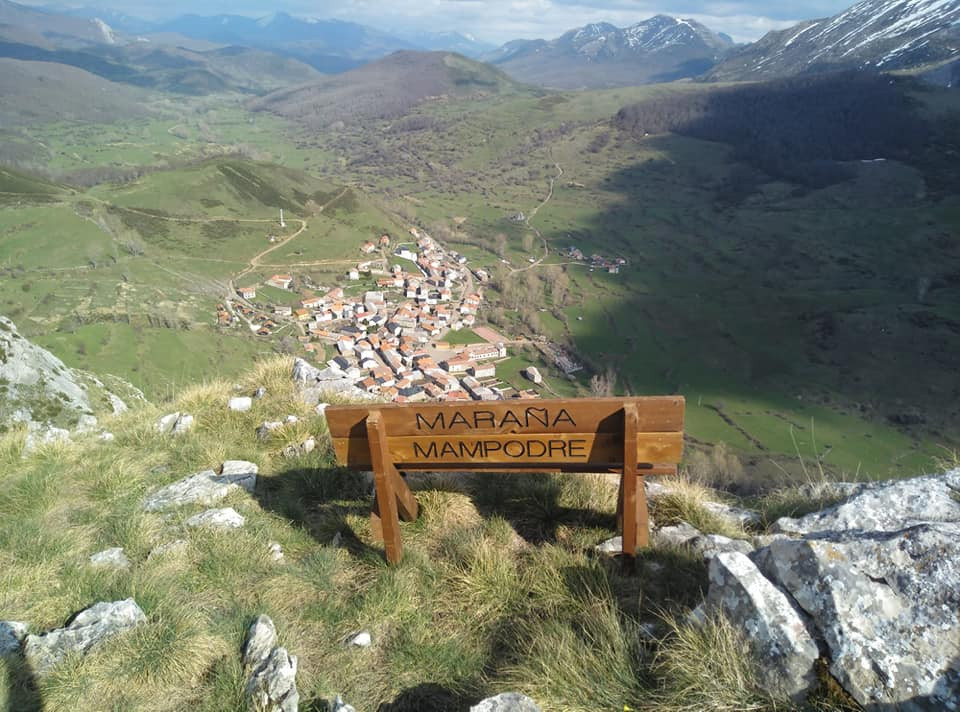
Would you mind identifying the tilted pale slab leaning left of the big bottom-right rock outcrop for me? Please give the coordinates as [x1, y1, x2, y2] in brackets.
[706, 552, 820, 702]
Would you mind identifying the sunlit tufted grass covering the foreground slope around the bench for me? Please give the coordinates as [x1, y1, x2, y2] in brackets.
[0, 360, 860, 712]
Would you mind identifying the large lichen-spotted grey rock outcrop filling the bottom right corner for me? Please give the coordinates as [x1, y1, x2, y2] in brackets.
[708, 469, 960, 710]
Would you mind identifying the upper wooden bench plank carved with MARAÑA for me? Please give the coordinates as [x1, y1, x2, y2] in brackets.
[326, 396, 684, 439]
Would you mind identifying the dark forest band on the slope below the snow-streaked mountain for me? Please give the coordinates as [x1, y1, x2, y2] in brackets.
[615, 72, 927, 186]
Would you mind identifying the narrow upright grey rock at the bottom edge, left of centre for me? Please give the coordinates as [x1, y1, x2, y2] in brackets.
[243, 615, 300, 712]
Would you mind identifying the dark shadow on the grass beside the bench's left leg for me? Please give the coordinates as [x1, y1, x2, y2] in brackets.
[254, 462, 383, 559]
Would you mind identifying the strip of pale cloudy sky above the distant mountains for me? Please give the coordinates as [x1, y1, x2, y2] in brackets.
[30, 0, 855, 44]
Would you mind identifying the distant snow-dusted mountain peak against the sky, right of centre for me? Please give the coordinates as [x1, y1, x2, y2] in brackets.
[484, 15, 733, 89]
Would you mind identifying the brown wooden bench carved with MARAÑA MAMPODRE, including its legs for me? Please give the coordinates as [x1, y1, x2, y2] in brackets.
[326, 396, 684, 563]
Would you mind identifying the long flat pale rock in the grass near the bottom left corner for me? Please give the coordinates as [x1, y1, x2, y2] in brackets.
[24, 598, 147, 675]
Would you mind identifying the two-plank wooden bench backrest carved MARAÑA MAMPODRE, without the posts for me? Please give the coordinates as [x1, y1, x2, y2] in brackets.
[326, 396, 684, 472]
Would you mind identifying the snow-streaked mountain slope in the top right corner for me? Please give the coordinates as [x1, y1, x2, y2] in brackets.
[710, 0, 960, 80]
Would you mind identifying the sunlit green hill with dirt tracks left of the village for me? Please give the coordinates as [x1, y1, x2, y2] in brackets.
[0, 159, 395, 397]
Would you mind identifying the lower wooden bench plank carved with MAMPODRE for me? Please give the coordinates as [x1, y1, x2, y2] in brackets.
[333, 432, 683, 471]
